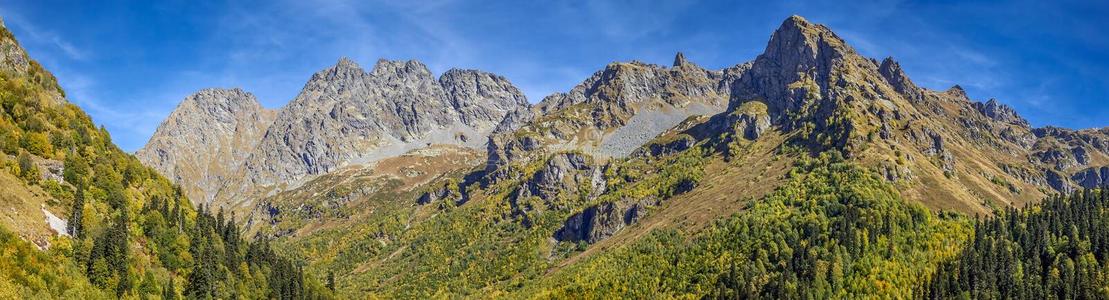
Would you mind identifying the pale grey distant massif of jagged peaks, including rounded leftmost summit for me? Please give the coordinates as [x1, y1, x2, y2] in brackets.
[139, 59, 529, 208]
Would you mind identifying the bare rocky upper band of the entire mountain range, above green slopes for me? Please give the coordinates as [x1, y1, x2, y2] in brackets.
[138, 14, 1109, 219]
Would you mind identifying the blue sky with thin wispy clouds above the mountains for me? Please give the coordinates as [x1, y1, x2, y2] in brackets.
[0, 0, 1109, 151]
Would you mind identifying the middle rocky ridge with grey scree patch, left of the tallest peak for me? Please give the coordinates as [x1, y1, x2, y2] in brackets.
[488, 53, 747, 170]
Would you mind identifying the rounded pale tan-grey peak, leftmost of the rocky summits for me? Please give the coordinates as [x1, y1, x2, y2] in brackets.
[135, 89, 275, 207]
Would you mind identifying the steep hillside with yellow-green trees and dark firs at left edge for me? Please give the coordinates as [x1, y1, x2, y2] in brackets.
[0, 17, 332, 299]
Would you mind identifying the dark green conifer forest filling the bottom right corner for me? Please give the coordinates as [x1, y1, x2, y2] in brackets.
[916, 189, 1109, 299]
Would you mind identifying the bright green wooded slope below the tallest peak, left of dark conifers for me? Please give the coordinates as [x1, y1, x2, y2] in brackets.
[520, 153, 968, 298]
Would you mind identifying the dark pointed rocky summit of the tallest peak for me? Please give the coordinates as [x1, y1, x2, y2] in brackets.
[731, 15, 896, 153]
